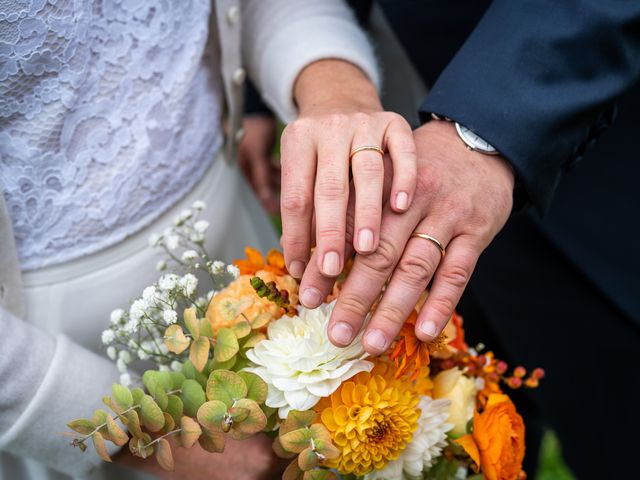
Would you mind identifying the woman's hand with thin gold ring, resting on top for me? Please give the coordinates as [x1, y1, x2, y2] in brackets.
[281, 60, 416, 284]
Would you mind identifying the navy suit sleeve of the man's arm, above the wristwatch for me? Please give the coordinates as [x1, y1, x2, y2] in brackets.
[421, 0, 640, 212]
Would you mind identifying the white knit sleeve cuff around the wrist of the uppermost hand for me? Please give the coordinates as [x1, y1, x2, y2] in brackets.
[254, 16, 380, 122]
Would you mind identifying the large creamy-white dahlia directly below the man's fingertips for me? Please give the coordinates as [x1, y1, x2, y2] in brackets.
[246, 302, 373, 418]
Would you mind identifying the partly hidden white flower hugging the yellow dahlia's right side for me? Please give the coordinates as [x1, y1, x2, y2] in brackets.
[364, 396, 453, 480]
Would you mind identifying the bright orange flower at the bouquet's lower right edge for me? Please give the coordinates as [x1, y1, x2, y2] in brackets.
[456, 394, 524, 480]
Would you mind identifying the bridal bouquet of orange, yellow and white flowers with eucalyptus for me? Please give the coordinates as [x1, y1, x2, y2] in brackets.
[68, 202, 543, 480]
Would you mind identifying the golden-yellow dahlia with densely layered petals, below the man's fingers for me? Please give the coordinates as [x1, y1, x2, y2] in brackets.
[316, 363, 420, 476]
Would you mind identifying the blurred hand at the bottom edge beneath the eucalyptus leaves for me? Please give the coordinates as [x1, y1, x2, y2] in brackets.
[113, 434, 286, 480]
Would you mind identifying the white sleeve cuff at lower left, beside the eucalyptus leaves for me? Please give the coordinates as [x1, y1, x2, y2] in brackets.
[0, 336, 124, 476]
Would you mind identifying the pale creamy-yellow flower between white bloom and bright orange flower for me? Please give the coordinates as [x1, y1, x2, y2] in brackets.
[433, 367, 477, 436]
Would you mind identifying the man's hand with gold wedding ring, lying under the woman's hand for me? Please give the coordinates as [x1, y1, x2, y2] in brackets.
[301, 121, 514, 354]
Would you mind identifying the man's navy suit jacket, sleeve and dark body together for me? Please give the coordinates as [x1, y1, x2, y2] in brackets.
[378, 0, 640, 325]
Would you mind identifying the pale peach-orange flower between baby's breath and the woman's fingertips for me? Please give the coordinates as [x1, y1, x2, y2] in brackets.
[207, 270, 298, 335]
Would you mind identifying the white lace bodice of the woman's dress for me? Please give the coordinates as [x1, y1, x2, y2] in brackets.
[0, 0, 222, 270]
